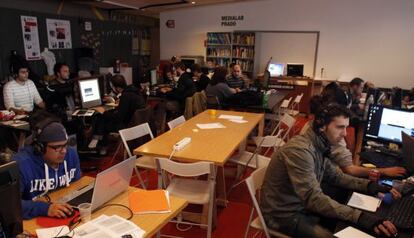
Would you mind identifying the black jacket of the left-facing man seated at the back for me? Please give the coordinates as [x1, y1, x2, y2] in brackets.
[167, 72, 196, 104]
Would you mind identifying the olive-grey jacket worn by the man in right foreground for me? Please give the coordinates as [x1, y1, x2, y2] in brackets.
[261, 129, 369, 223]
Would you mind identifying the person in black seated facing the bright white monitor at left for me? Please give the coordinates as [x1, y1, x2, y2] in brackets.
[91, 74, 146, 148]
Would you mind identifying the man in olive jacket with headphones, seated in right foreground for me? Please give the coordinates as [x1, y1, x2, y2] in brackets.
[261, 104, 401, 238]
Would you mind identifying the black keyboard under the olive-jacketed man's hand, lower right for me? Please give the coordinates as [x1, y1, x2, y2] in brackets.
[383, 196, 414, 230]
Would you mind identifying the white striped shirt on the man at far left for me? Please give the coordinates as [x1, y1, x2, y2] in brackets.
[3, 79, 43, 112]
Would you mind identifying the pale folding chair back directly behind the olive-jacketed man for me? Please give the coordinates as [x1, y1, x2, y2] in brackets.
[246, 167, 270, 238]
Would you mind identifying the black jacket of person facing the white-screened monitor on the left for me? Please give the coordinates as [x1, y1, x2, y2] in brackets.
[113, 85, 145, 126]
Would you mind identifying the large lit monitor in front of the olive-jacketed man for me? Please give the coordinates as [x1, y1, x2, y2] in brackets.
[365, 104, 414, 144]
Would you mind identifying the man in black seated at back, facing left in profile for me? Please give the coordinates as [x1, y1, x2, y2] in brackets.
[160, 62, 196, 112]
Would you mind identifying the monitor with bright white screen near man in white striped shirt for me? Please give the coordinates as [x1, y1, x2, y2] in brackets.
[78, 78, 102, 108]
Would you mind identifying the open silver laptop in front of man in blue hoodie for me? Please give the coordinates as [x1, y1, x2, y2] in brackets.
[67, 156, 136, 211]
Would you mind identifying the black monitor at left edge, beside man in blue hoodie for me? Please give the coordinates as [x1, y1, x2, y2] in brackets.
[0, 161, 23, 237]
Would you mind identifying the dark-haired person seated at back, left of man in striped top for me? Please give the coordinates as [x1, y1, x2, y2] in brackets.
[206, 67, 240, 103]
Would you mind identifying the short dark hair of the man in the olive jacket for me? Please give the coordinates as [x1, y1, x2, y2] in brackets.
[313, 103, 351, 131]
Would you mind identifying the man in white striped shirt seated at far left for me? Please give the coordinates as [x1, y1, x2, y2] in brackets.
[3, 63, 45, 114]
